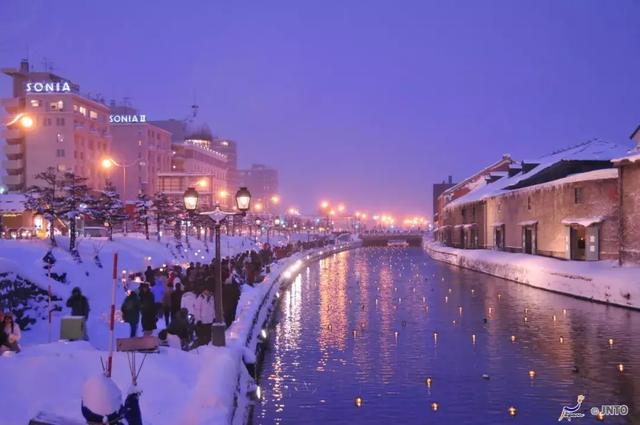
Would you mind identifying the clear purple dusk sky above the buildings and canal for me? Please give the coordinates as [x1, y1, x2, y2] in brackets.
[0, 0, 640, 214]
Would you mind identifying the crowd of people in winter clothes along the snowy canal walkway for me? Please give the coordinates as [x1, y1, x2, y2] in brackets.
[0, 240, 336, 354]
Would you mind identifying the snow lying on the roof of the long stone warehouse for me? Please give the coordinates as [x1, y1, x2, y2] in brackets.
[445, 139, 628, 208]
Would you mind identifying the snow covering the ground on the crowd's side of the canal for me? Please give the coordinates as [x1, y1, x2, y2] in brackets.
[0, 235, 356, 425]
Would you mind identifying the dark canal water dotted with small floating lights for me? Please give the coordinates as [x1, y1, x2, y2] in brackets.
[252, 248, 640, 425]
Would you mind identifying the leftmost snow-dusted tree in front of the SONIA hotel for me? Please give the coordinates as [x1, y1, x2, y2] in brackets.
[25, 167, 60, 246]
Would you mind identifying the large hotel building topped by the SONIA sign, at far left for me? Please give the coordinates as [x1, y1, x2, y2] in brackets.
[2, 60, 111, 192]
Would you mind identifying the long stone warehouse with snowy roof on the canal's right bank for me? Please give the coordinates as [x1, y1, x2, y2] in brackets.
[436, 140, 640, 261]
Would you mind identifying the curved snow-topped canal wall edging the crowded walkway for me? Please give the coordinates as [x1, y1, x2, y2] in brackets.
[229, 242, 361, 425]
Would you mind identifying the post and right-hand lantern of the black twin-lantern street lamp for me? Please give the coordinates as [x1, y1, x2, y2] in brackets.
[200, 187, 251, 347]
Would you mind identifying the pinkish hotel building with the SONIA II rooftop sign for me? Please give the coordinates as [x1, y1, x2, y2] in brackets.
[109, 102, 172, 200]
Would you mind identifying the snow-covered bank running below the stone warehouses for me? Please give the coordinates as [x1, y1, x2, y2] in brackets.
[424, 241, 640, 309]
